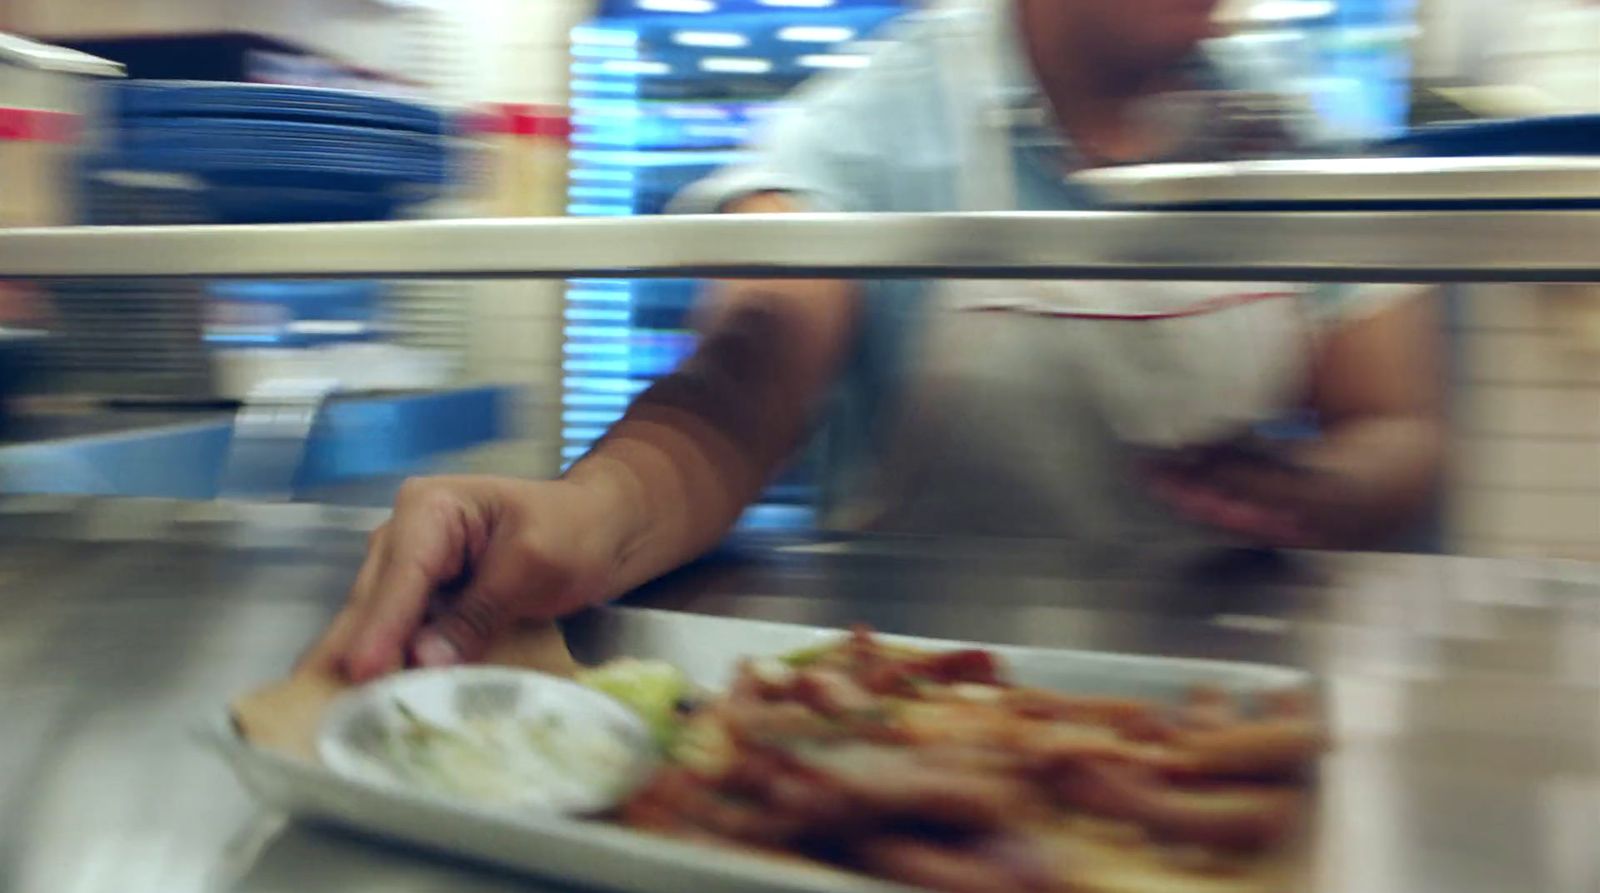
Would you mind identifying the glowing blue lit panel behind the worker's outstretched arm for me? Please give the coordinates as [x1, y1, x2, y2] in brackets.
[562, 0, 901, 517]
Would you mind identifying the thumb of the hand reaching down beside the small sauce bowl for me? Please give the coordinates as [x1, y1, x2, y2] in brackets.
[411, 541, 568, 667]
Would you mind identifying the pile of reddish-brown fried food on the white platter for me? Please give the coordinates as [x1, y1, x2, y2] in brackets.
[621, 629, 1323, 893]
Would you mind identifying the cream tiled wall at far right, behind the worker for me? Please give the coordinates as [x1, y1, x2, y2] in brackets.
[1424, 0, 1600, 560]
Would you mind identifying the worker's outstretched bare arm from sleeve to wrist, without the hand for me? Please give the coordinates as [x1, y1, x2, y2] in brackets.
[566, 194, 856, 597]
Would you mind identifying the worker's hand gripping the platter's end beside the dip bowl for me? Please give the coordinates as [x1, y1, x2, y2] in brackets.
[301, 477, 627, 682]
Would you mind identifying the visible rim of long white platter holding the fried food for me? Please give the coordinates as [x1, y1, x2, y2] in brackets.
[203, 608, 1312, 893]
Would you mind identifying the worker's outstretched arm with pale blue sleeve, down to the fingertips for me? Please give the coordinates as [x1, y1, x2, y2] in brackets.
[315, 52, 915, 680]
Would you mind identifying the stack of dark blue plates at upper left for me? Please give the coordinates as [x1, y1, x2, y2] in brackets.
[85, 80, 450, 222]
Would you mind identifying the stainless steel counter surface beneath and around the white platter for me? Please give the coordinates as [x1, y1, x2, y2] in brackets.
[0, 496, 1600, 893]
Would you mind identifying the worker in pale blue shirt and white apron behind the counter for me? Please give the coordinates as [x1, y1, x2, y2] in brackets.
[315, 0, 1440, 679]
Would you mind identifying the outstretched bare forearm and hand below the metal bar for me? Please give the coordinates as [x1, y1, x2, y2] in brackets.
[314, 283, 843, 680]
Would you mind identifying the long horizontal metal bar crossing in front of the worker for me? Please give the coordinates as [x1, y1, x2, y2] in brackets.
[0, 211, 1600, 282]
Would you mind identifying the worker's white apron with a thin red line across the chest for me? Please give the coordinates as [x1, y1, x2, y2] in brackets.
[845, 10, 1315, 554]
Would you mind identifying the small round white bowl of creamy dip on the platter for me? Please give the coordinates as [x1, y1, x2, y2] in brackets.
[317, 667, 656, 815]
